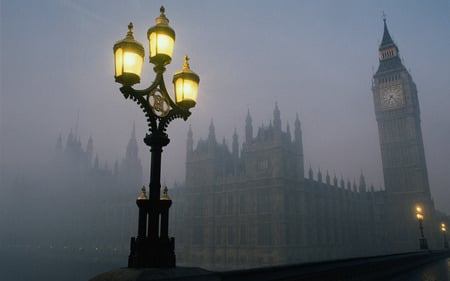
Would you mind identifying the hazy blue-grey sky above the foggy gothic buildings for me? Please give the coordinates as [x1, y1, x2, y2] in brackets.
[0, 0, 450, 213]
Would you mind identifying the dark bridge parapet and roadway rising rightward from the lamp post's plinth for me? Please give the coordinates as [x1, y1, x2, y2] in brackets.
[221, 251, 450, 281]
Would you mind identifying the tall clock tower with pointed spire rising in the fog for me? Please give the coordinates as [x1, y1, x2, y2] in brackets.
[372, 19, 434, 252]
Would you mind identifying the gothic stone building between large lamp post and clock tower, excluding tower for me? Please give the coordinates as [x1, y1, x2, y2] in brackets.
[171, 103, 385, 269]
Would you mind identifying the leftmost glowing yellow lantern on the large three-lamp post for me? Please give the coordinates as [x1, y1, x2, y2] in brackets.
[113, 23, 144, 86]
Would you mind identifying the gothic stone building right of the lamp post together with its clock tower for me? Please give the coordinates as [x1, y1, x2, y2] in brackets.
[171, 21, 448, 269]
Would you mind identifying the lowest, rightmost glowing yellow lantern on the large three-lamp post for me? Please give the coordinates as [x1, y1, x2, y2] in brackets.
[173, 56, 200, 109]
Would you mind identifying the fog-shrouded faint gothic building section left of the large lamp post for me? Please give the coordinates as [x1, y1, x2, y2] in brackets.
[0, 123, 143, 253]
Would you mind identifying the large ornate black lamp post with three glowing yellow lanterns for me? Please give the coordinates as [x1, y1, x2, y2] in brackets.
[113, 7, 200, 268]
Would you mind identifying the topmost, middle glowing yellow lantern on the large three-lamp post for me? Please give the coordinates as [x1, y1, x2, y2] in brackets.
[147, 6, 175, 66]
